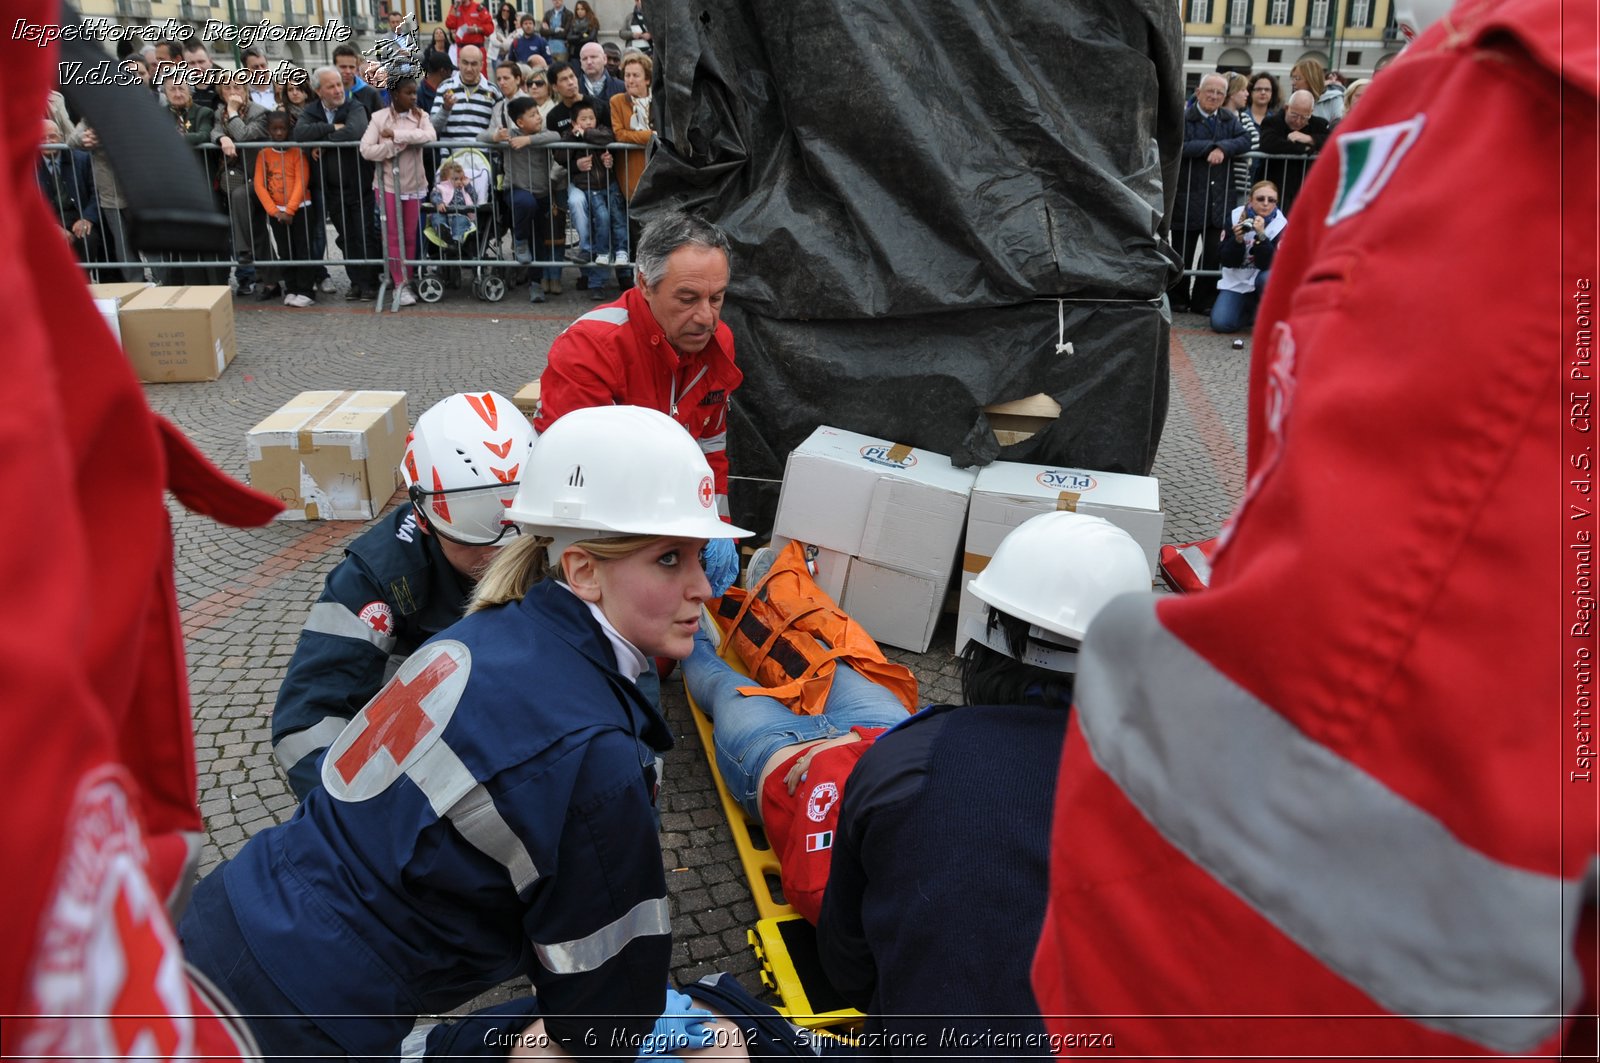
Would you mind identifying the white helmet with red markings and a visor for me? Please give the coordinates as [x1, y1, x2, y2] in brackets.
[400, 391, 536, 546]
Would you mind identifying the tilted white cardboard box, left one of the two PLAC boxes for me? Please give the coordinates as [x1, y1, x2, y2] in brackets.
[773, 427, 976, 653]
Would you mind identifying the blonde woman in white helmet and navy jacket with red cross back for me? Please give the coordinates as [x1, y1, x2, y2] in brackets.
[179, 407, 746, 1058]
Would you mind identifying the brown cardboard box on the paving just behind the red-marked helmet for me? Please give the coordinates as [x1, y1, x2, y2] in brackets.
[245, 391, 410, 520]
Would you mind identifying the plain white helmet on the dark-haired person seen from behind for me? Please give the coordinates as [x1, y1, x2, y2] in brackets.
[965, 511, 1150, 672]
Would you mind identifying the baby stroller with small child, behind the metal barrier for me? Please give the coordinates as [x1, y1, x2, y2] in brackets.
[416, 147, 507, 303]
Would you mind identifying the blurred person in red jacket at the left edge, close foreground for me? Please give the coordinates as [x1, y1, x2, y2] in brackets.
[0, 3, 280, 1060]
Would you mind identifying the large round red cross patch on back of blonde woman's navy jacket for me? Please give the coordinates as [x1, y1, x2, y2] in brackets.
[322, 639, 472, 800]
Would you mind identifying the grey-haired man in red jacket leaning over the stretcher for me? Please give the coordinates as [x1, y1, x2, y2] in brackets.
[533, 211, 744, 594]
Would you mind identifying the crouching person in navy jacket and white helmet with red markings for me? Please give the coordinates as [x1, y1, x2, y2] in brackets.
[272, 391, 533, 799]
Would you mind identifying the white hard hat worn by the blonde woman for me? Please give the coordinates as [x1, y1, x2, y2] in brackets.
[506, 407, 750, 559]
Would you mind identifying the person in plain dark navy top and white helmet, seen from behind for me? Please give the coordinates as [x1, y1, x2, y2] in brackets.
[818, 512, 1150, 1058]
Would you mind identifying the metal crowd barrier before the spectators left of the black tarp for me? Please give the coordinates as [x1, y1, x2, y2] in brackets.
[40, 141, 643, 311]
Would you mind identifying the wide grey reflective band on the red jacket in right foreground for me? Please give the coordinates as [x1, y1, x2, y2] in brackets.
[1075, 594, 1600, 1052]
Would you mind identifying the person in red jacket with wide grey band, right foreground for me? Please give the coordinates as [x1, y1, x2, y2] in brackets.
[1034, 0, 1600, 1058]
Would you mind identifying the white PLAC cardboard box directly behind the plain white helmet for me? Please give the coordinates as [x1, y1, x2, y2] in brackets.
[955, 461, 1166, 653]
